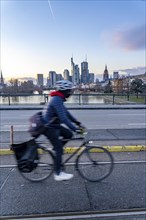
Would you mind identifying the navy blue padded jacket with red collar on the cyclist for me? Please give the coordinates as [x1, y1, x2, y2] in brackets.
[43, 91, 78, 131]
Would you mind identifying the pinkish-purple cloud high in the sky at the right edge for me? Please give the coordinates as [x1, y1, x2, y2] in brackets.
[111, 25, 146, 51]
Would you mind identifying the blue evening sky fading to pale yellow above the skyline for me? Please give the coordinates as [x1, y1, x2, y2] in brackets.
[0, 0, 146, 81]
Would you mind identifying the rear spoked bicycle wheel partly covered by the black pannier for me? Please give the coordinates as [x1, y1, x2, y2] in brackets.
[20, 147, 54, 182]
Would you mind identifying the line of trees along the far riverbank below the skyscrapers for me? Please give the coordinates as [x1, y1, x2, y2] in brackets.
[0, 78, 146, 97]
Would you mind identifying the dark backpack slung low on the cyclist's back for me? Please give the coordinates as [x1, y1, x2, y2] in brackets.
[28, 112, 45, 138]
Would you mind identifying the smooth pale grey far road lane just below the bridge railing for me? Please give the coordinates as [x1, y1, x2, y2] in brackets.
[0, 109, 146, 131]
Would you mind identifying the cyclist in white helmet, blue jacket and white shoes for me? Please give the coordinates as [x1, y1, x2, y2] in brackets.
[43, 80, 82, 181]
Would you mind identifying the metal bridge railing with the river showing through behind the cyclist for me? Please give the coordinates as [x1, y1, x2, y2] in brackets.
[0, 93, 146, 105]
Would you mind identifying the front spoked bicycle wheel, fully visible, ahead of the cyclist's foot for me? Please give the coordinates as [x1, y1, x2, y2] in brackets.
[76, 146, 114, 182]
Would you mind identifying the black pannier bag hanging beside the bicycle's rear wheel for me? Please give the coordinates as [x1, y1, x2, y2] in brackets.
[11, 139, 39, 173]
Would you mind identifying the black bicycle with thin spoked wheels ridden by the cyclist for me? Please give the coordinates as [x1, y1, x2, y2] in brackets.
[17, 131, 114, 182]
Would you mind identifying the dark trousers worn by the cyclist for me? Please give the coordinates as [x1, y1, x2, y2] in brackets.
[44, 126, 73, 174]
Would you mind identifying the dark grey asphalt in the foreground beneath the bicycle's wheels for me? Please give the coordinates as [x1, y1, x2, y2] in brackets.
[0, 152, 146, 219]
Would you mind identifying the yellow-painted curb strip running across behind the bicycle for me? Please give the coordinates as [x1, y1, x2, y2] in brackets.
[0, 145, 146, 156]
